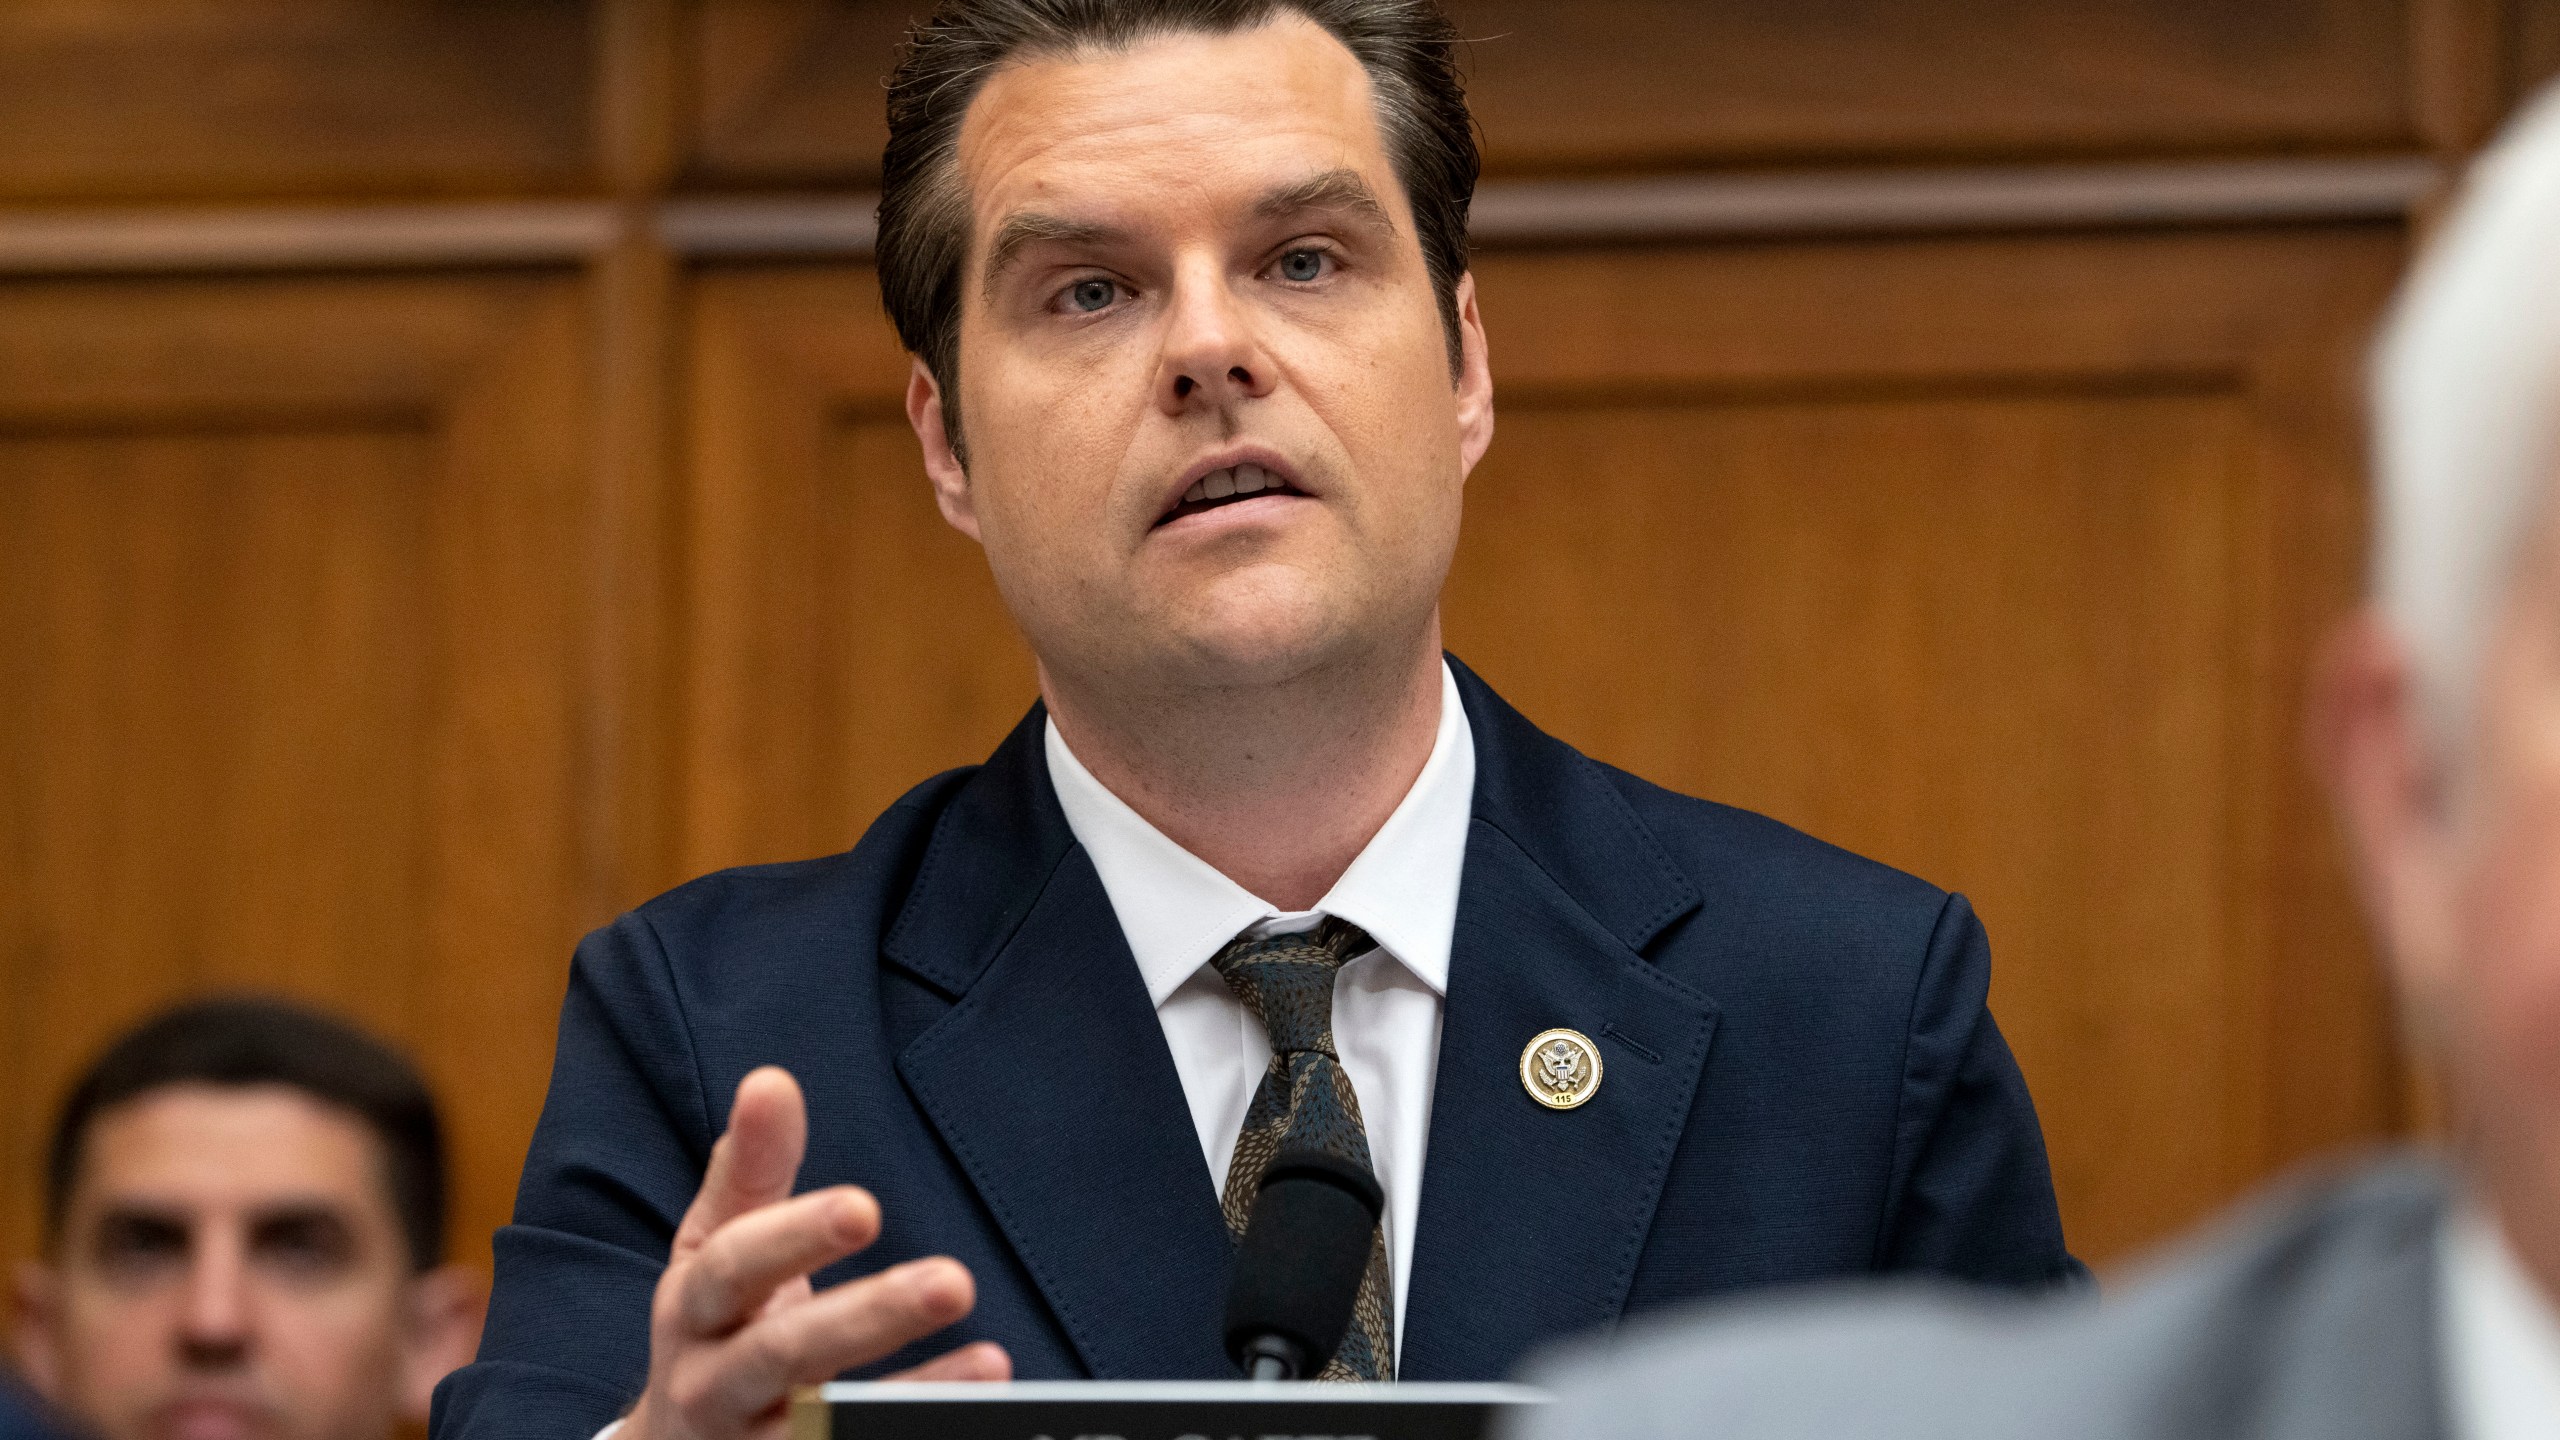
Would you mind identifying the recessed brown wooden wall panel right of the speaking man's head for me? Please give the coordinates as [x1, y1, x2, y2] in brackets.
[1449, 392, 2252, 1258]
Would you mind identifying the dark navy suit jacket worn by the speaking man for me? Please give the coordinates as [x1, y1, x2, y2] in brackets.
[435, 666, 2079, 1440]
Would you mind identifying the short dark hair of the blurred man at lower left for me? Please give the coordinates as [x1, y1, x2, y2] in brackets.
[44, 997, 445, 1271]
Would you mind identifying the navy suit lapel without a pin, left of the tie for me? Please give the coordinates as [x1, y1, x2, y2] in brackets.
[886, 707, 1231, 1379]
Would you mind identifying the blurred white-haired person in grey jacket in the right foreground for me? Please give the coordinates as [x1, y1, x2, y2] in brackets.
[1513, 90, 2560, 1440]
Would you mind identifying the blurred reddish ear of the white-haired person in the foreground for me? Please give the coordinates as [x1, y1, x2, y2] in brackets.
[2309, 610, 2458, 1017]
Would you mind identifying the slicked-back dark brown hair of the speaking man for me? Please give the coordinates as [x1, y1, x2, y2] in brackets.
[876, 0, 1480, 446]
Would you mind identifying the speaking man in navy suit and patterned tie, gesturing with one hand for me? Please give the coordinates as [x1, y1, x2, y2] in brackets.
[440, 0, 2076, 1440]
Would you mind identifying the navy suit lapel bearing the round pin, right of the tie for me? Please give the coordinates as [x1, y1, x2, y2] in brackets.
[1398, 666, 1718, 1381]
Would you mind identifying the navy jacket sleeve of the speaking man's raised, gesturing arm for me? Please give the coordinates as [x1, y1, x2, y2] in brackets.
[430, 912, 717, 1440]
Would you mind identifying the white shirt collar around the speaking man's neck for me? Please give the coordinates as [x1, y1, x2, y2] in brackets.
[1042, 661, 1475, 1004]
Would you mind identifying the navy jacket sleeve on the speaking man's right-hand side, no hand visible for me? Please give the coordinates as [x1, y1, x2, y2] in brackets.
[1874, 894, 2089, 1286]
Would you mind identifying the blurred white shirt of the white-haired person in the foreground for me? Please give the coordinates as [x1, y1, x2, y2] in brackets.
[2437, 1204, 2560, 1440]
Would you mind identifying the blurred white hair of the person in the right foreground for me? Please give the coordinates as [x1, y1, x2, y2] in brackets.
[2371, 87, 2560, 746]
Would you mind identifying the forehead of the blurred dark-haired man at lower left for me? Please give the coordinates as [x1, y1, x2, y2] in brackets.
[72, 1084, 389, 1209]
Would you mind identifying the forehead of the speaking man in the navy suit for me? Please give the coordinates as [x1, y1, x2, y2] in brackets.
[960, 15, 1400, 236]
